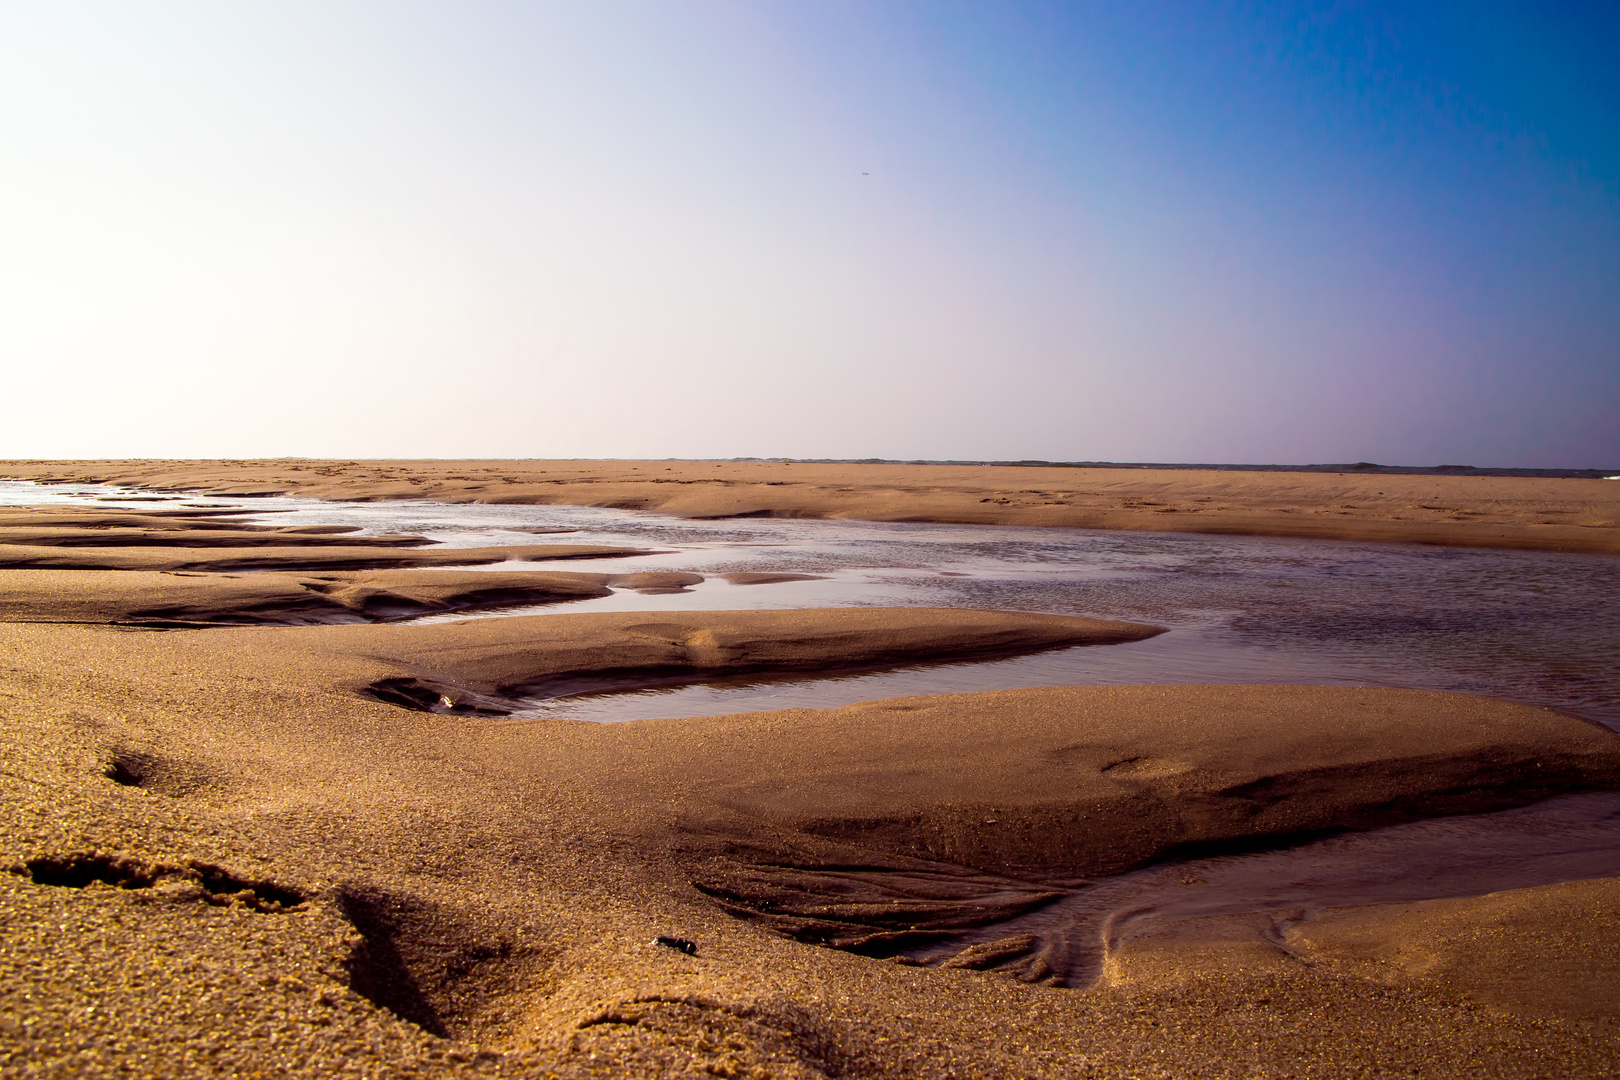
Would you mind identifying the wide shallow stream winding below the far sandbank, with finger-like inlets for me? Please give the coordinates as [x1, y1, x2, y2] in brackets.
[0, 483, 1620, 727]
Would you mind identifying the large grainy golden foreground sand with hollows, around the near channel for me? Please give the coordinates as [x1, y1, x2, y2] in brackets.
[0, 612, 1620, 1077]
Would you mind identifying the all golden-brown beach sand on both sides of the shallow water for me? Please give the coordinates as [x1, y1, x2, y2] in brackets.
[0, 463, 1620, 1078]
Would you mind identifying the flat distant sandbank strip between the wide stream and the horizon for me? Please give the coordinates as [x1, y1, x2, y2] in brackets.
[0, 460, 1620, 554]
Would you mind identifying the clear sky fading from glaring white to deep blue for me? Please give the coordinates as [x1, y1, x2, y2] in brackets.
[0, 0, 1620, 468]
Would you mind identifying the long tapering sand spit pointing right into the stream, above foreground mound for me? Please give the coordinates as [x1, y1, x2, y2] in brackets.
[192, 607, 1162, 712]
